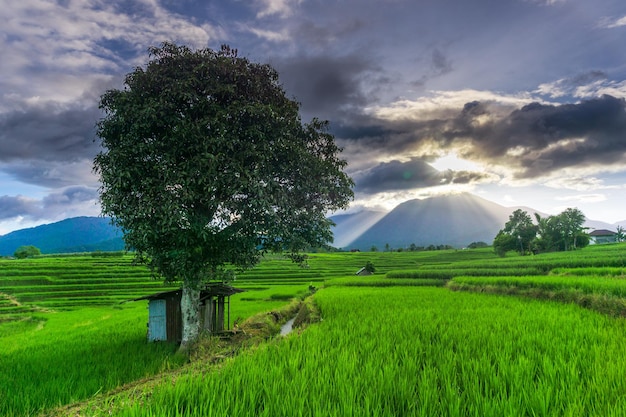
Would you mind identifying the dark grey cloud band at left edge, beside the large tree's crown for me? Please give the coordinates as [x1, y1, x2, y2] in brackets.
[0, 103, 100, 162]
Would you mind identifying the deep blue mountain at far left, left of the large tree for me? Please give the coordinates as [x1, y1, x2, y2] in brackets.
[0, 217, 124, 256]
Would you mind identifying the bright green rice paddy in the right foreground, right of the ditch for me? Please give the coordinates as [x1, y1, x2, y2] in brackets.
[79, 287, 626, 417]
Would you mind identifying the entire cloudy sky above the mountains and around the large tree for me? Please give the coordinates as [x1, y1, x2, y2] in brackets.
[0, 0, 626, 235]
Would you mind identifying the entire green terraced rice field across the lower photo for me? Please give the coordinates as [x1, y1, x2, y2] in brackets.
[0, 244, 626, 417]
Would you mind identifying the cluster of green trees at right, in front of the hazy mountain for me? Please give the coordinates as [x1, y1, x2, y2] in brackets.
[493, 208, 590, 256]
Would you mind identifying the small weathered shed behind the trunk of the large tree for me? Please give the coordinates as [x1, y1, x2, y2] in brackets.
[133, 283, 244, 343]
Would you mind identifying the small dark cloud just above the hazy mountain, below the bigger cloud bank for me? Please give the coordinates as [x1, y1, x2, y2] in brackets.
[354, 158, 493, 194]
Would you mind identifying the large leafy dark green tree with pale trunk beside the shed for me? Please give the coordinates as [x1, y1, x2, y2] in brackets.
[94, 43, 353, 350]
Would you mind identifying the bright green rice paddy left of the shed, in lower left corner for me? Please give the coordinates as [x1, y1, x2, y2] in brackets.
[0, 303, 183, 416]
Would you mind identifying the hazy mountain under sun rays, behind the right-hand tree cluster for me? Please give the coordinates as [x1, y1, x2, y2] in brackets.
[331, 194, 615, 250]
